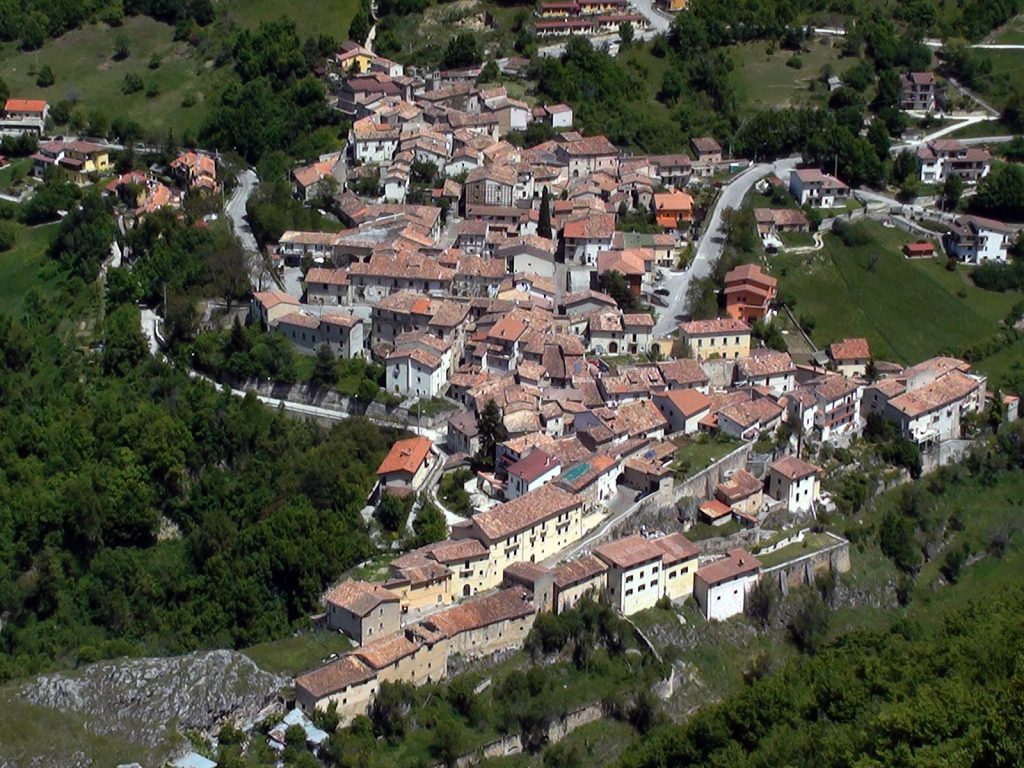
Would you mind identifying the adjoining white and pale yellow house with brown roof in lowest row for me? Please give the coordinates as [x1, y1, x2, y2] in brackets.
[594, 534, 700, 615]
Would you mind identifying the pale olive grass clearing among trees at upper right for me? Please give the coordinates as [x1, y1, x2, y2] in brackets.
[730, 42, 857, 110]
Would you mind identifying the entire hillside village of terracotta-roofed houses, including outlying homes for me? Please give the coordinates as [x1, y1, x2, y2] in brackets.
[0, 9, 1019, 765]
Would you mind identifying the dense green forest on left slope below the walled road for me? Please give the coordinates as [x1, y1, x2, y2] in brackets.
[0, 209, 391, 679]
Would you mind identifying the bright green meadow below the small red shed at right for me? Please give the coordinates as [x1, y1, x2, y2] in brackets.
[772, 222, 1019, 362]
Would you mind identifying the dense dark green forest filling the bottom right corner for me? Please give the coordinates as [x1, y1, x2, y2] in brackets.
[620, 586, 1024, 768]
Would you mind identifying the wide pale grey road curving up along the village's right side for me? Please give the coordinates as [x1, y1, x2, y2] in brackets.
[654, 158, 801, 338]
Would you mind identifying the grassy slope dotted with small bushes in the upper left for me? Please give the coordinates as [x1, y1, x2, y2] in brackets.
[0, 16, 230, 138]
